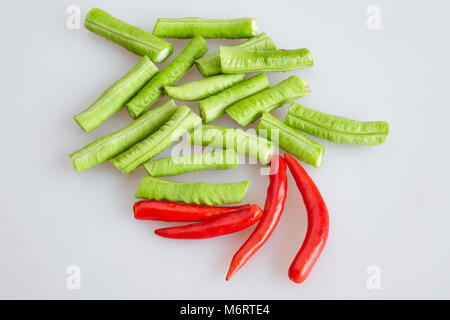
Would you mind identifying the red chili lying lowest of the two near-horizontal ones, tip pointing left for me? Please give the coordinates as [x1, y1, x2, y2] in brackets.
[155, 204, 262, 239]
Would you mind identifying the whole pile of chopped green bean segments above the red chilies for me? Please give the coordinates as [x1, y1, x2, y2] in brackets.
[70, 8, 389, 205]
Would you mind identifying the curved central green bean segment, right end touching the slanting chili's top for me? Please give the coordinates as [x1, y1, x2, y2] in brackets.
[191, 125, 276, 164]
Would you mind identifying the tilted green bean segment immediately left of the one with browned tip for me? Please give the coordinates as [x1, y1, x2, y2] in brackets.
[198, 73, 269, 123]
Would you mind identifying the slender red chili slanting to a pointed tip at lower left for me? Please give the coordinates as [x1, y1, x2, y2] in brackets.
[226, 155, 287, 280]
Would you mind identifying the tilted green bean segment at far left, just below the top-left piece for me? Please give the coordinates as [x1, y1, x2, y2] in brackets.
[74, 56, 158, 132]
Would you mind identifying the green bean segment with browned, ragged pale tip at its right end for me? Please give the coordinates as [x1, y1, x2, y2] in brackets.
[225, 76, 311, 127]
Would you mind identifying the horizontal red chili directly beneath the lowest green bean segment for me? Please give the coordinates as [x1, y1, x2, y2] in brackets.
[133, 200, 250, 222]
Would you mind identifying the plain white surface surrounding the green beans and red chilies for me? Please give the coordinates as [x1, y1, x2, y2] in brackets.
[0, 0, 450, 299]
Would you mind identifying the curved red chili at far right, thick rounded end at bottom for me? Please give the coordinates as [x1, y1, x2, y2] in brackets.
[284, 154, 329, 283]
